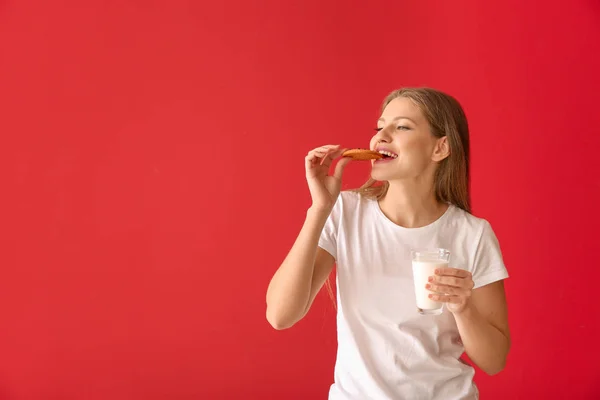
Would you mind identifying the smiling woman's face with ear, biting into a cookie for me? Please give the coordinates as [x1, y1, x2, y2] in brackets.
[370, 97, 447, 181]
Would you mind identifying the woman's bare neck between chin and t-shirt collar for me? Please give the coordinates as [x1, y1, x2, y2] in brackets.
[379, 181, 448, 228]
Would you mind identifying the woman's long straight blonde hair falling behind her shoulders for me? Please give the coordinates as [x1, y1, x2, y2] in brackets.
[325, 87, 471, 308]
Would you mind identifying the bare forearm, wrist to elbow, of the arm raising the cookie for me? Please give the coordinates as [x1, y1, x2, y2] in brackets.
[267, 208, 330, 327]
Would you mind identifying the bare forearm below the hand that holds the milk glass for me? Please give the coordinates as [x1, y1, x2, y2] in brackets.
[455, 307, 510, 375]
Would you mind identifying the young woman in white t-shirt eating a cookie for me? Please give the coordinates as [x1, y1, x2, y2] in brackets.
[267, 88, 510, 400]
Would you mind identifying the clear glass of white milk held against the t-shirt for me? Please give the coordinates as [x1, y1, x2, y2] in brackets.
[411, 249, 450, 315]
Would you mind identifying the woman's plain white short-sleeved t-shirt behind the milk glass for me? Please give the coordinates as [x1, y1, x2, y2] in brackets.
[319, 192, 508, 400]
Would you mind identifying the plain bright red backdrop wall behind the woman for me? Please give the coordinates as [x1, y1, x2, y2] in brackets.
[0, 0, 600, 400]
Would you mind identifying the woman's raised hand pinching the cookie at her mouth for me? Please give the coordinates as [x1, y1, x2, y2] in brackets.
[305, 145, 352, 210]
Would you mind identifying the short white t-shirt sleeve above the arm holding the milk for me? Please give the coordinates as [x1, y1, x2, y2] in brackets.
[473, 220, 508, 289]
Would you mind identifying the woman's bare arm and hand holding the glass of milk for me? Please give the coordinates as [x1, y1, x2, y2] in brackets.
[428, 268, 510, 375]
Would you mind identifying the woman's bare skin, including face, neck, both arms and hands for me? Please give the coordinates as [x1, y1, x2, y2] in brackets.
[267, 98, 510, 375]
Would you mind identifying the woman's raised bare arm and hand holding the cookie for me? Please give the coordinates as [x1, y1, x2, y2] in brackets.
[267, 145, 350, 329]
